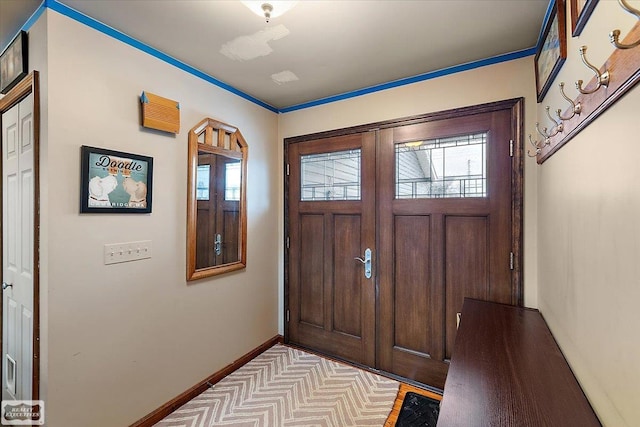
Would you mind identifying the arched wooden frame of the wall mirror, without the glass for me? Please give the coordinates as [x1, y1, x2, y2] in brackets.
[187, 118, 249, 281]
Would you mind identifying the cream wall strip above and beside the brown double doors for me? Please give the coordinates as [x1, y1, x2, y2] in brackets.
[278, 56, 538, 331]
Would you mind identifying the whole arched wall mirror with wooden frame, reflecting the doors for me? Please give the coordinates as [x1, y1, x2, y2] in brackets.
[187, 118, 248, 280]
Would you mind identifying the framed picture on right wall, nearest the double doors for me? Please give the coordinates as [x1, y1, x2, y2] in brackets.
[534, 0, 567, 102]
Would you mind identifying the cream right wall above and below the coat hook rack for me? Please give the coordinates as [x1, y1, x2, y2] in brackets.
[538, 0, 640, 427]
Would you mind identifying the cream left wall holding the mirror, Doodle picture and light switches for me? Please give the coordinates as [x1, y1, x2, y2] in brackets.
[40, 10, 279, 427]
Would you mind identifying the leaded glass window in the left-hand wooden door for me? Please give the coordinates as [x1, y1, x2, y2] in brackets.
[300, 149, 361, 201]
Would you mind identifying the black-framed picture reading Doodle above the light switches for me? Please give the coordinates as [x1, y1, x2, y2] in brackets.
[80, 145, 153, 213]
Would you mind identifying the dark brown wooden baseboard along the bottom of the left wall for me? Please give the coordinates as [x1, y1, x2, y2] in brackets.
[129, 335, 284, 427]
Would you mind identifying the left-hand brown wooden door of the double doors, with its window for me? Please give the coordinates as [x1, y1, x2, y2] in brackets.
[287, 132, 375, 366]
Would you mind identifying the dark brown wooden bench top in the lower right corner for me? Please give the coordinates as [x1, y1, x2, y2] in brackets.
[438, 298, 601, 427]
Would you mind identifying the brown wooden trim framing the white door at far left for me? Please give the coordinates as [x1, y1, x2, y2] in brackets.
[0, 71, 40, 400]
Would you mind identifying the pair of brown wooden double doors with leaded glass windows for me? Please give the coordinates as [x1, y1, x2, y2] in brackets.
[285, 100, 522, 388]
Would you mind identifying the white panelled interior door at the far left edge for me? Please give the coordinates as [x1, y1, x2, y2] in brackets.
[2, 95, 35, 400]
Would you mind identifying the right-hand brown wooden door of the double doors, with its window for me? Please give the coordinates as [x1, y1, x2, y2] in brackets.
[377, 110, 517, 388]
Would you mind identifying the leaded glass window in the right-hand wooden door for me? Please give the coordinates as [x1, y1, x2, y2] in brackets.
[395, 132, 487, 199]
